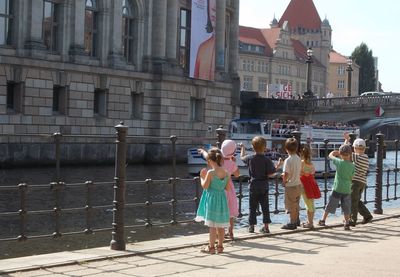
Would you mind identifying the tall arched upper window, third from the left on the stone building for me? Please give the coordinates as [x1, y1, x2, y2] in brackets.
[85, 0, 98, 57]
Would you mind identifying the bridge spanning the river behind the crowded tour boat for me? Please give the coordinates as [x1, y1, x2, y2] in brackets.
[241, 91, 400, 134]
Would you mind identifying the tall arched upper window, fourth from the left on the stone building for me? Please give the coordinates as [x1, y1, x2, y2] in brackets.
[122, 0, 134, 63]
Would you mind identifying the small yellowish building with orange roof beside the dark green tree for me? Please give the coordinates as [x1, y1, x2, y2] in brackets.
[328, 50, 360, 97]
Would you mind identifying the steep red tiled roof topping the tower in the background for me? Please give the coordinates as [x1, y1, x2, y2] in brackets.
[279, 0, 321, 30]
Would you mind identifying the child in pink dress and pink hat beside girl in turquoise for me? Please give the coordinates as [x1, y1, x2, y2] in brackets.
[221, 139, 239, 240]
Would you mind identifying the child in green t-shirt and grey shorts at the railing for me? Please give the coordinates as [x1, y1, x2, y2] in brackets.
[318, 144, 354, 230]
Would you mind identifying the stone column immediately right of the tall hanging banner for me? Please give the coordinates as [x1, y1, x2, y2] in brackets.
[215, 0, 226, 71]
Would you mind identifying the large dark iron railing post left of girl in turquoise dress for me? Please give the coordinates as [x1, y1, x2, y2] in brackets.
[110, 122, 128, 250]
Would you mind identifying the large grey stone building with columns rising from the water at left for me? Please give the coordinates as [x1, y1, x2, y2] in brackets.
[0, 0, 240, 163]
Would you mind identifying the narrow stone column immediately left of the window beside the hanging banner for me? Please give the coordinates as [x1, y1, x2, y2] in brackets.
[166, 0, 179, 63]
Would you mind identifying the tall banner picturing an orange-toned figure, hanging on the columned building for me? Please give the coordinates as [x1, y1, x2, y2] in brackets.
[189, 0, 217, 81]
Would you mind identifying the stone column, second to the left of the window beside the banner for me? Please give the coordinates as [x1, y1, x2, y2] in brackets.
[152, 0, 167, 60]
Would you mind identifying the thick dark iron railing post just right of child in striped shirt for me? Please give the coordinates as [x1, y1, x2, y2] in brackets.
[374, 132, 385, 214]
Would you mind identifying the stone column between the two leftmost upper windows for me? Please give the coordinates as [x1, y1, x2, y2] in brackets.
[25, 0, 46, 50]
